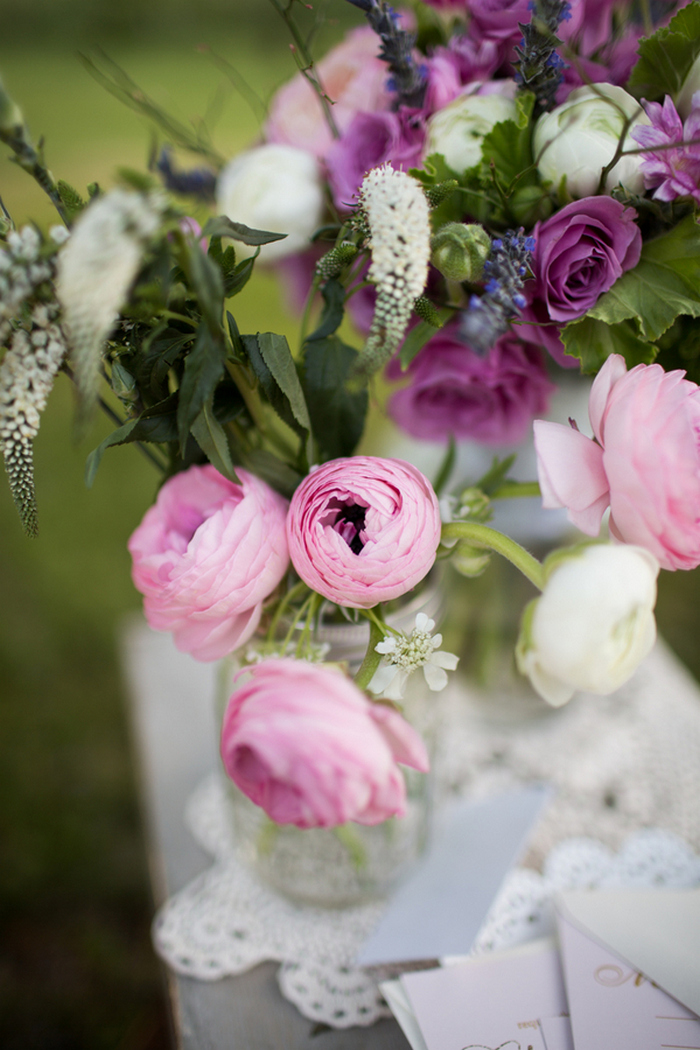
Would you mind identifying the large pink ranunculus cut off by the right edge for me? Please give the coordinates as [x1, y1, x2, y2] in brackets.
[534, 354, 700, 569]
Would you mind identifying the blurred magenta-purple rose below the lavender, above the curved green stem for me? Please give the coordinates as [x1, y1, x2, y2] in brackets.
[387, 322, 554, 445]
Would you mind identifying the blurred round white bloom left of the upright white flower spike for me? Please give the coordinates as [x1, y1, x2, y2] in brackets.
[216, 143, 324, 263]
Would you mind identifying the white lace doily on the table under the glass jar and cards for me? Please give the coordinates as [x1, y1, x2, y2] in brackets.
[154, 653, 700, 1028]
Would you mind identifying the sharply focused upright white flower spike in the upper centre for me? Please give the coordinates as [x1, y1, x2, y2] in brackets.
[358, 164, 430, 376]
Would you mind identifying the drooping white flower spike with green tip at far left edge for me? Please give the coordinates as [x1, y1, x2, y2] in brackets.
[0, 303, 66, 536]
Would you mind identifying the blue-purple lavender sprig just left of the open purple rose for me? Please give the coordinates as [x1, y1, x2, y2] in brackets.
[461, 227, 535, 354]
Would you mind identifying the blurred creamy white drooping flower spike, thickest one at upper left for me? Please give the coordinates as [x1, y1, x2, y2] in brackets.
[56, 189, 165, 405]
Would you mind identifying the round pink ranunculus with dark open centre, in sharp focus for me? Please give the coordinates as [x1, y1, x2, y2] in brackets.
[287, 456, 441, 609]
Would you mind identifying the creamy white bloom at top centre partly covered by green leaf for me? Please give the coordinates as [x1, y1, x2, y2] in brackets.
[425, 95, 517, 175]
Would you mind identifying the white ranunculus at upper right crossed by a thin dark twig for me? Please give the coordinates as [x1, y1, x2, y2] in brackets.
[533, 84, 650, 197]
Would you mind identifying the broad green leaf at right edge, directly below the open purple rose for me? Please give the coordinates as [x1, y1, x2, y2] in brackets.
[561, 215, 700, 372]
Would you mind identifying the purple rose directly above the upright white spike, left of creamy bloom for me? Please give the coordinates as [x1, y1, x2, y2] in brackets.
[326, 106, 425, 211]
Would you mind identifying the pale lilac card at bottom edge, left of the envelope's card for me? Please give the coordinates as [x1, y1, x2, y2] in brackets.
[401, 941, 570, 1050]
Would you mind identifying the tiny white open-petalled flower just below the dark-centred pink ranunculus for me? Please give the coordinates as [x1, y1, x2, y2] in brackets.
[367, 612, 459, 700]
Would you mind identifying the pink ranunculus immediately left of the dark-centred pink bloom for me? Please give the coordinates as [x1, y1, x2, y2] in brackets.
[128, 464, 289, 660]
